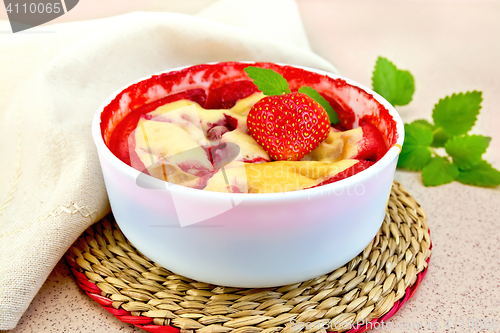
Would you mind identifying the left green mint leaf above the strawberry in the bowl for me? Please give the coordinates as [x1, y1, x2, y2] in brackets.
[245, 66, 290, 96]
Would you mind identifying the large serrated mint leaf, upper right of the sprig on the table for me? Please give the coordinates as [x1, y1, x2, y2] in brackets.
[432, 91, 483, 136]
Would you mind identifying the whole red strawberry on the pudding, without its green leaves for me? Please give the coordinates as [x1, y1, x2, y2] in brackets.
[247, 92, 330, 161]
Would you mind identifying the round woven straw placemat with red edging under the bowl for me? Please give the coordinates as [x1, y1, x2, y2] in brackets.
[66, 182, 432, 333]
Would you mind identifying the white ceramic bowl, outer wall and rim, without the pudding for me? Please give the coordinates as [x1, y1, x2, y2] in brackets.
[92, 61, 404, 287]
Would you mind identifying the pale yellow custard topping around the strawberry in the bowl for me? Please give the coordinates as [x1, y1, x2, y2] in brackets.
[129, 93, 363, 193]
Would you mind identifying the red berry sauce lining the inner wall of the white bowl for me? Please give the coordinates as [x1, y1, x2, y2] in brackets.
[101, 62, 398, 186]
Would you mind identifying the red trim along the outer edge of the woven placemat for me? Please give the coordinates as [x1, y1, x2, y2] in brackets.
[66, 230, 432, 333]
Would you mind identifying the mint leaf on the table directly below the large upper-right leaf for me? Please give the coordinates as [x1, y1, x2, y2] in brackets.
[444, 135, 491, 170]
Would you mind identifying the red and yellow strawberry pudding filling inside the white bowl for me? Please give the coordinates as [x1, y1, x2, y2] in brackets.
[101, 63, 396, 193]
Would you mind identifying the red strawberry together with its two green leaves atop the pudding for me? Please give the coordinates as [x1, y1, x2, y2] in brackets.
[245, 66, 339, 161]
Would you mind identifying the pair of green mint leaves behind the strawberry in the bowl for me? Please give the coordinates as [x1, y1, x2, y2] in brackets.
[245, 66, 340, 124]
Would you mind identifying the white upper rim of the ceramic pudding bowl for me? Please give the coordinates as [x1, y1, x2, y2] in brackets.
[92, 61, 405, 202]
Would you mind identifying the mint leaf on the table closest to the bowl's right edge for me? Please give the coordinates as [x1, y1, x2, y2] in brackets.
[398, 123, 433, 171]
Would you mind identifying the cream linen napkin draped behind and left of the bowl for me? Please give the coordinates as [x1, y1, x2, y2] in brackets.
[0, 0, 336, 329]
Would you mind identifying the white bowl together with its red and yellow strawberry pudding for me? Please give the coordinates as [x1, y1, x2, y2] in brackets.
[92, 62, 404, 288]
